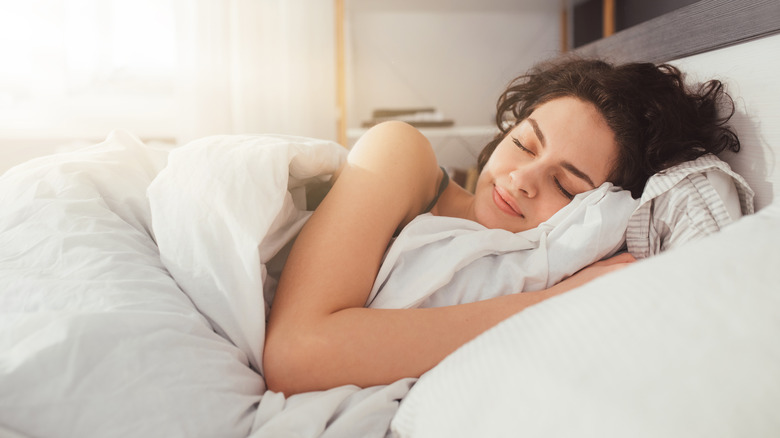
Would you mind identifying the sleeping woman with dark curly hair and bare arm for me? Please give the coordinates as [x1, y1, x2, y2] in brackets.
[263, 59, 739, 395]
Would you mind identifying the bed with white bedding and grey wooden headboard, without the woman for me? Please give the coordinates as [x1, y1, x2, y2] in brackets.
[0, 1, 780, 437]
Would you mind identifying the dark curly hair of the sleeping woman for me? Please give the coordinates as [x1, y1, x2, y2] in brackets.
[477, 57, 740, 198]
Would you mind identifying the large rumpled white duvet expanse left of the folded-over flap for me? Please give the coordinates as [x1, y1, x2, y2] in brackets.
[0, 133, 263, 437]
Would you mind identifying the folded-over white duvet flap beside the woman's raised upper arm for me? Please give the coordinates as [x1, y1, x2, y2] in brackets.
[147, 135, 346, 373]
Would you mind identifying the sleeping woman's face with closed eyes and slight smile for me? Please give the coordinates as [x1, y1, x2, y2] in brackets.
[473, 97, 618, 232]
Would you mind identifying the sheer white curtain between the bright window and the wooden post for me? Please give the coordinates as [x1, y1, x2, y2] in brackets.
[175, 0, 337, 143]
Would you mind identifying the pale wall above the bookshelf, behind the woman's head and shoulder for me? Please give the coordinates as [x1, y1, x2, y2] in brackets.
[346, 0, 560, 128]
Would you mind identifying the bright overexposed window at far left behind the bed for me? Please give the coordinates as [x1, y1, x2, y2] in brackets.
[0, 0, 176, 138]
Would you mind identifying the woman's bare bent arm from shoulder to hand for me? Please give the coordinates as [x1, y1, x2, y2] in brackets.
[263, 123, 632, 395]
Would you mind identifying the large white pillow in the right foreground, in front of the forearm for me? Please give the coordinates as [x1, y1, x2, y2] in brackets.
[392, 200, 780, 438]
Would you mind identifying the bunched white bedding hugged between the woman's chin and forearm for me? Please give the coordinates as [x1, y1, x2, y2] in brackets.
[368, 183, 638, 309]
